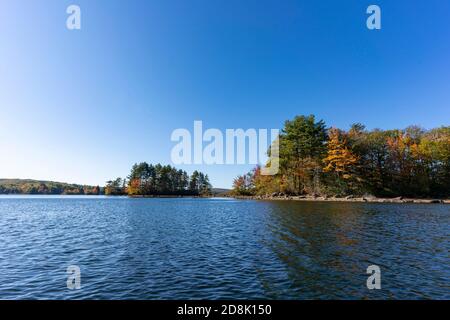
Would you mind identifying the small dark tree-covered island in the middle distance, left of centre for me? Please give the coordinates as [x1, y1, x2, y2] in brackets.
[105, 162, 212, 196]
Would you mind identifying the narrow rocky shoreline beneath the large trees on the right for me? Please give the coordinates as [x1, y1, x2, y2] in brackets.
[232, 194, 450, 204]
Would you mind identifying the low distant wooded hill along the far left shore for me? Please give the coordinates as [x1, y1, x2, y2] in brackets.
[0, 179, 103, 195]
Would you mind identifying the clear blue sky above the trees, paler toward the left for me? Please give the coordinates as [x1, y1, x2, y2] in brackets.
[0, 0, 450, 187]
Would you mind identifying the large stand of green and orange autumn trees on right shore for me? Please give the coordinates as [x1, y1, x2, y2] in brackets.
[232, 115, 450, 198]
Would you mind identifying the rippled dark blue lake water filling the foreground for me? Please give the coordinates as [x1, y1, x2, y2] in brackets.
[0, 196, 450, 299]
